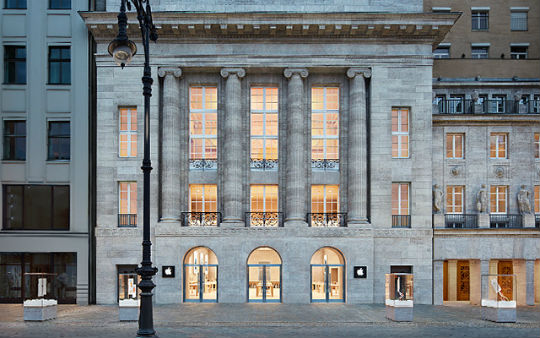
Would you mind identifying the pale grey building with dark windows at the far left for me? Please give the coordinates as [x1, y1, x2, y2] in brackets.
[0, 0, 91, 304]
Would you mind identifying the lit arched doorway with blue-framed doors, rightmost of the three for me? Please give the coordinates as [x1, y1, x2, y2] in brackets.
[311, 247, 345, 302]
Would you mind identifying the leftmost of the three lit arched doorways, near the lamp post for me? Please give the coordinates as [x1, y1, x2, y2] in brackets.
[184, 247, 218, 302]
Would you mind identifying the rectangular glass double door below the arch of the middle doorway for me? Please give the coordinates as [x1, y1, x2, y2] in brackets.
[248, 264, 281, 303]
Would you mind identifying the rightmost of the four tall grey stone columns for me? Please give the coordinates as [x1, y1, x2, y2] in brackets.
[347, 68, 371, 226]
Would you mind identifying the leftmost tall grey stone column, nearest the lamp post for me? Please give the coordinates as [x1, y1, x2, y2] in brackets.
[158, 67, 182, 222]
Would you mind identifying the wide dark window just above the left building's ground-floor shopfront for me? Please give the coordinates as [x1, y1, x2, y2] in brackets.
[3, 185, 70, 230]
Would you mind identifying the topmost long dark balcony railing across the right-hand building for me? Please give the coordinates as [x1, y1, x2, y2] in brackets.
[433, 99, 540, 114]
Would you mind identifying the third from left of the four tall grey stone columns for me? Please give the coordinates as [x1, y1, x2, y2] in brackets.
[284, 68, 309, 226]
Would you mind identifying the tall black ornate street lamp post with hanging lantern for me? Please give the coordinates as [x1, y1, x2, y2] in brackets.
[109, 0, 157, 337]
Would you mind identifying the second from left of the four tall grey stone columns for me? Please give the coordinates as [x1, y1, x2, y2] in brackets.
[221, 68, 246, 224]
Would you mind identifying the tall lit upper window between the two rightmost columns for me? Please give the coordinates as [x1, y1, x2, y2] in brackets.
[311, 87, 339, 161]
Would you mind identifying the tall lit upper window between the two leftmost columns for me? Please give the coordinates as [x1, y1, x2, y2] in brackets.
[189, 87, 217, 160]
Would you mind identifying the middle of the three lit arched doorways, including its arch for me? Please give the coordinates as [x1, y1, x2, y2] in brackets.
[248, 247, 281, 303]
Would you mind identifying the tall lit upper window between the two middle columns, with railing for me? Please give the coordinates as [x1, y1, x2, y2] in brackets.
[251, 87, 278, 169]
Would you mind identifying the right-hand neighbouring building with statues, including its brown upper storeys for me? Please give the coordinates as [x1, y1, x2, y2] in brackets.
[424, 0, 540, 305]
